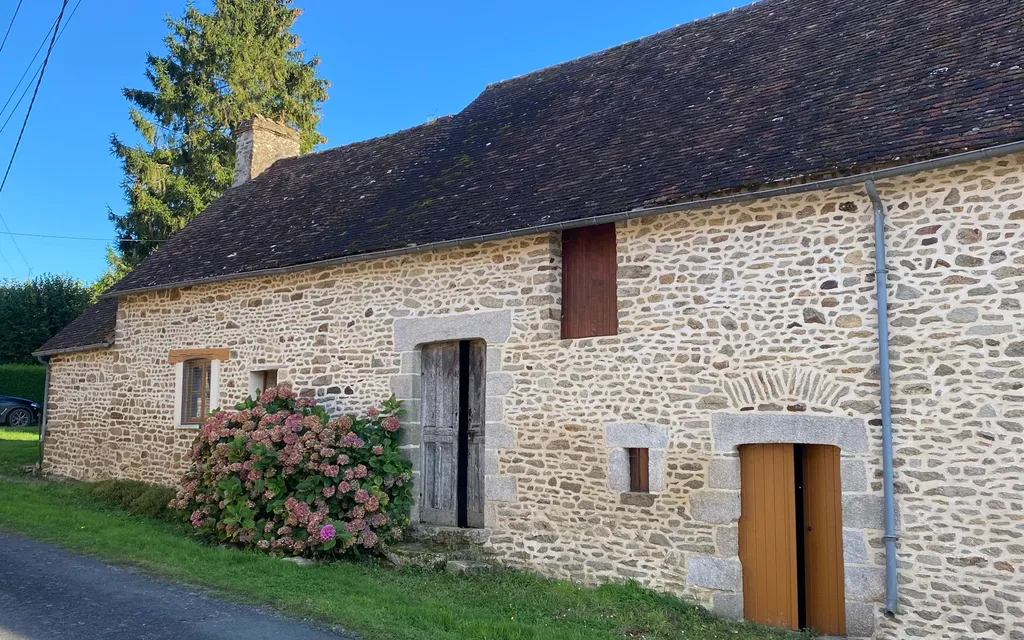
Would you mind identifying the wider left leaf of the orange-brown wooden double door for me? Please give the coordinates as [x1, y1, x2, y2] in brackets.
[739, 444, 800, 630]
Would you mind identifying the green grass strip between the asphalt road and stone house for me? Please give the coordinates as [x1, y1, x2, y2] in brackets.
[0, 431, 800, 640]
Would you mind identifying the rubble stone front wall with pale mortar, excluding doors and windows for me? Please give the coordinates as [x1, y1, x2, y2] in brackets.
[46, 152, 1024, 638]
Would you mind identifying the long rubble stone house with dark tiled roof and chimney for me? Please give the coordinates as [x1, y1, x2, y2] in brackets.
[38, 0, 1024, 639]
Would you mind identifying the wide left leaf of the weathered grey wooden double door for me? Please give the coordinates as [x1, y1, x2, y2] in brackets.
[420, 342, 460, 526]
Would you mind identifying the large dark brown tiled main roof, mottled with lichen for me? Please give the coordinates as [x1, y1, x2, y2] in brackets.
[103, 0, 1024, 294]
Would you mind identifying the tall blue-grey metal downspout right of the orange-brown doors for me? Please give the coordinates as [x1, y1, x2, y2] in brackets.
[865, 180, 899, 615]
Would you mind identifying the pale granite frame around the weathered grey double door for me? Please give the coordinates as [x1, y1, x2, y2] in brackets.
[391, 309, 518, 528]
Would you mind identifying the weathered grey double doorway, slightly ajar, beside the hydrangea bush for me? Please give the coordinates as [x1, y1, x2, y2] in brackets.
[420, 340, 486, 527]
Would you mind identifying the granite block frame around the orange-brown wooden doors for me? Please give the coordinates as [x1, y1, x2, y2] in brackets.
[686, 412, 885, 638]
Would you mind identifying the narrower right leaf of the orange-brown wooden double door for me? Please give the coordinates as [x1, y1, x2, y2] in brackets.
[803, 444, 846, 636]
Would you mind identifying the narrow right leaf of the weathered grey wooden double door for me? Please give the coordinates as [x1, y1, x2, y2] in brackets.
[465, 340, 487, 528]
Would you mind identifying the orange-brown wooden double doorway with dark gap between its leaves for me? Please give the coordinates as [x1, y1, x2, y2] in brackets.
[739, 443, 846, 636]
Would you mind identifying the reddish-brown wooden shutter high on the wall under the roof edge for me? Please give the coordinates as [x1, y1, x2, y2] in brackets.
[562, 224, 618, 339]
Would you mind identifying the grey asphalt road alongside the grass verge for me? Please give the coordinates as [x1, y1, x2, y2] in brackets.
[0, 531, 354, 640]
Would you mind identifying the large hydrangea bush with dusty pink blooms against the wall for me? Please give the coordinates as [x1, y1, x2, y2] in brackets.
[170, 384, 413, 557]
